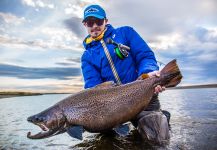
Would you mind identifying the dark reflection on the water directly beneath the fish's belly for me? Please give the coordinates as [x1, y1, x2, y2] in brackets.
[71, 130, 170, 150]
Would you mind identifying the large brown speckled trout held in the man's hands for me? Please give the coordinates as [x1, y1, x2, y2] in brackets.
[27, 60, 182, 139]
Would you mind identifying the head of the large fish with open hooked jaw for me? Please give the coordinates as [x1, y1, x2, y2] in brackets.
[27, 106, 66, 139]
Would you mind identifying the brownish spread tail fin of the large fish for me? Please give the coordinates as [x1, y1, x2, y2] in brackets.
[160, 59, 182, 87]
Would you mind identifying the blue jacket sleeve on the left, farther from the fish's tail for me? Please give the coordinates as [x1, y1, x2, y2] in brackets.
[81, 54, 102, 89]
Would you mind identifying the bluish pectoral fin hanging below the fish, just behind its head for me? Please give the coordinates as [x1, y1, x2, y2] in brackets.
[67, 126, 84, 140]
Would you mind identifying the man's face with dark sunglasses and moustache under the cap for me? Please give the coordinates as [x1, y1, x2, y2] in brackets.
[84, 17, 108, 38]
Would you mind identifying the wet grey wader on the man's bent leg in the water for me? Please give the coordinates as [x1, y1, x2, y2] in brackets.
[131, 95, 170, 144]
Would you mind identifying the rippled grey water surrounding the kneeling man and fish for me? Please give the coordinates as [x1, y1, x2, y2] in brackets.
[0, 88, 217, 150]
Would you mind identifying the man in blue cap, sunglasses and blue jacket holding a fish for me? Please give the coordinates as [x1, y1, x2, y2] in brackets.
[81, 5, 169, 142]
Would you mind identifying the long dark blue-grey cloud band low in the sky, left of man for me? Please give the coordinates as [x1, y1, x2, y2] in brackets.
[0, 64, 81, 80]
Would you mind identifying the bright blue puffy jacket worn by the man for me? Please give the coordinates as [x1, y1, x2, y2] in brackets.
[81, 24, 159, 88]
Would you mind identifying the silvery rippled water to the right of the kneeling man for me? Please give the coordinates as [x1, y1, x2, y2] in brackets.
[160, 89, 217, 149]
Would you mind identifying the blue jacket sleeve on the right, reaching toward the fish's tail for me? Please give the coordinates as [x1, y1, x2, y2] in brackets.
[126, 27, 159, 76]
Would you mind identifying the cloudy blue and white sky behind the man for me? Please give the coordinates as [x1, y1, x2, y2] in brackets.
[0, 0, 217, 92]
